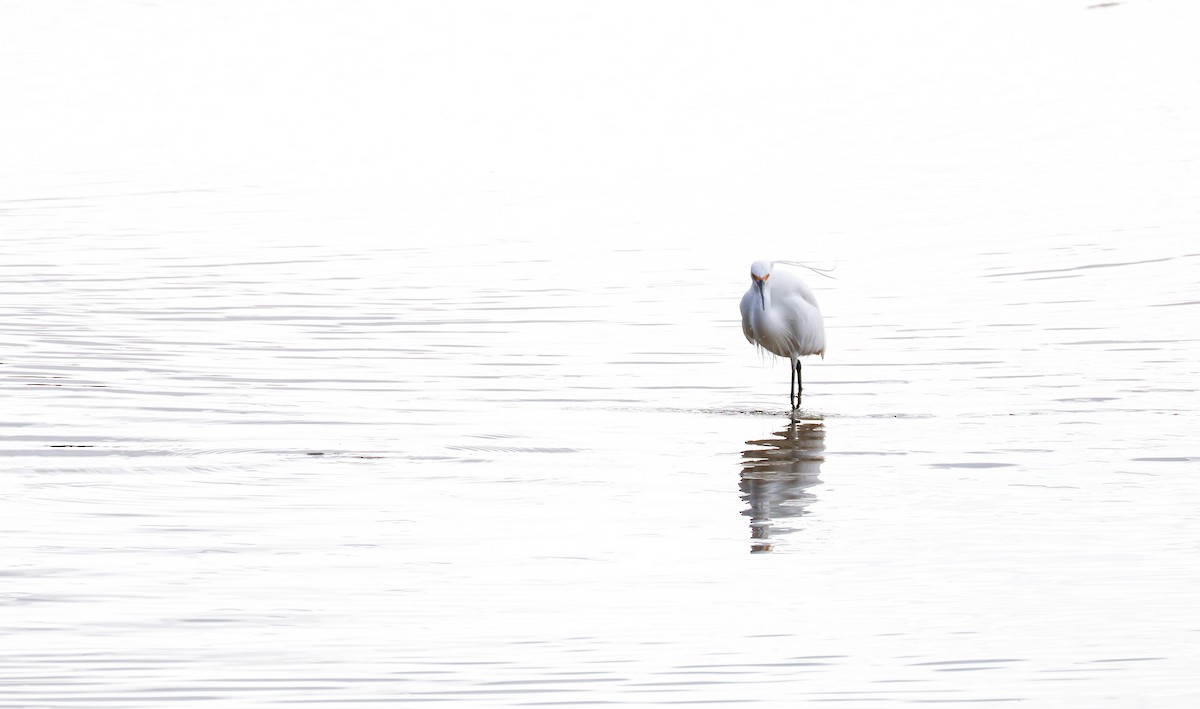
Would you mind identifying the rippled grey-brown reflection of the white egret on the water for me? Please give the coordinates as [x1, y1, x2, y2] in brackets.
[738, 419, 824, 552]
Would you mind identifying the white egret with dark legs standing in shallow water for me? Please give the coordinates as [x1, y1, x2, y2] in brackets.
[742, 262, 832, 410]
